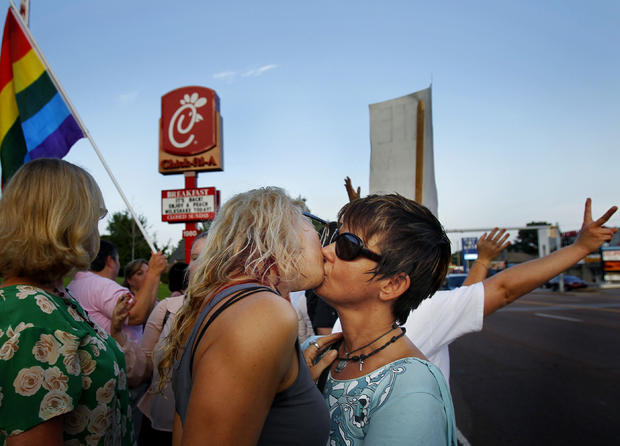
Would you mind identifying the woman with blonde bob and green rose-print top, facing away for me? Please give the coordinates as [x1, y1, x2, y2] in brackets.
[0, 158, 135, 446]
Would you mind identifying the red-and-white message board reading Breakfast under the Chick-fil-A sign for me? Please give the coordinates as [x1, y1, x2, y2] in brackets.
[161, 187, 219, 223]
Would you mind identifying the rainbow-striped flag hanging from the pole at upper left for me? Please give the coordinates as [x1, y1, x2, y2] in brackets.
[0, 8, 84, 187]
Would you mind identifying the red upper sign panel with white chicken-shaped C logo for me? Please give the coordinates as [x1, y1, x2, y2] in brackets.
[161, 86, 217, 156]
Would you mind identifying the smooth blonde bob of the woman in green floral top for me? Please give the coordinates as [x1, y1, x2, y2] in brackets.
[0, 158, 107, 284]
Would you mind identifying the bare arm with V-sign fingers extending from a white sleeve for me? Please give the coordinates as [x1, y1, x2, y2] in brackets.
[483, 198, 618, 316]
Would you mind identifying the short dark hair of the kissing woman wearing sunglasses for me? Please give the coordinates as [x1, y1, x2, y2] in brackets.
[338, 194, 450, 324]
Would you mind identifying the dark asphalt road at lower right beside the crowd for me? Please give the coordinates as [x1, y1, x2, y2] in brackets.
[450, 289, 620, 446]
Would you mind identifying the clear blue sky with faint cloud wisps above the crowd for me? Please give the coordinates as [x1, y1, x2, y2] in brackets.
[6, 0, 620, 249]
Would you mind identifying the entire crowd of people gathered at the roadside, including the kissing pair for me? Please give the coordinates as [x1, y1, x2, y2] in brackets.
[0, 158, 616, 446]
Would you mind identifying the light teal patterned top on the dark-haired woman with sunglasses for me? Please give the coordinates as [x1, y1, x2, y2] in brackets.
[323, 358, 456, 446]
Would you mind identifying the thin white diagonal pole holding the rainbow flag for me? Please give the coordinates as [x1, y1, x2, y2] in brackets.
[9, 0, 156, 252]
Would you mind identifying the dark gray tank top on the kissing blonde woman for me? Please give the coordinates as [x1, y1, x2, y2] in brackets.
[172, 283, 329, 446]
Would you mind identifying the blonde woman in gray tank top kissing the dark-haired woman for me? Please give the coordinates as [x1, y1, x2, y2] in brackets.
[160, 188, 329, 445]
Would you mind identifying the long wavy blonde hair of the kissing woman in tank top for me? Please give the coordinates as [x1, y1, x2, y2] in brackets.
[159, 187, 304, 378]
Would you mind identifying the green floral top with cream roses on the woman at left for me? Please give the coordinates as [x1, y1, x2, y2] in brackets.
[0, 285, 135, 445]
